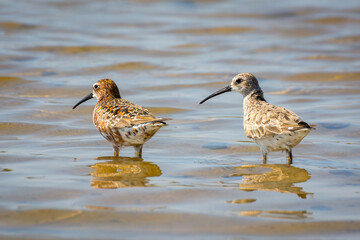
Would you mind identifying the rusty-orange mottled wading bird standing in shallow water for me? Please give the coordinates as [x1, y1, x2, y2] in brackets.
[73, 79, 171, 158]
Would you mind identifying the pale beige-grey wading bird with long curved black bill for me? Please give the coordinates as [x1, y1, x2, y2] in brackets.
[200, 73, 316, 164]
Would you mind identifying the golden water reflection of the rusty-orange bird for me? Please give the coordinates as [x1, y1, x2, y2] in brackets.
[90, 157, 161, 189]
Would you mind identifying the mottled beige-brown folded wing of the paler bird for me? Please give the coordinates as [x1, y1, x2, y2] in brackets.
[244, 103, 310, 139]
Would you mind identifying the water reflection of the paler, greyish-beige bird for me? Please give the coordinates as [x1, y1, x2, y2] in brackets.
[229, 164, 313, 198]
